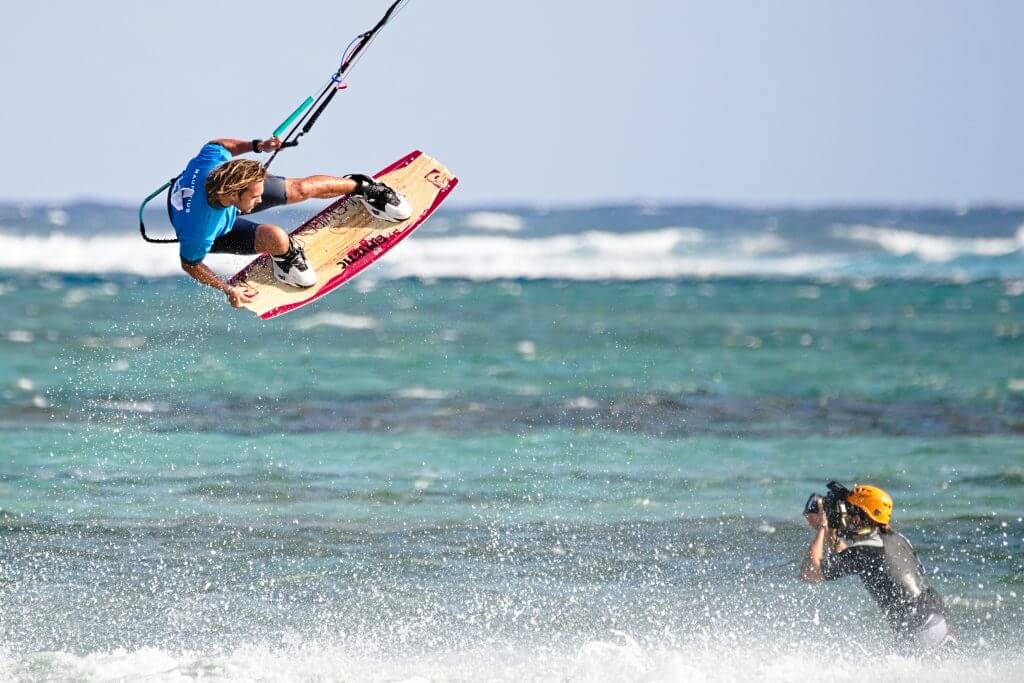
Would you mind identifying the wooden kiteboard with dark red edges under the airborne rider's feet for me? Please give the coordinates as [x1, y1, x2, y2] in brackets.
[230, 151, 459, 321]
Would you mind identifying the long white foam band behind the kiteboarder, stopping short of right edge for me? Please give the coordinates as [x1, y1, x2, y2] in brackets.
[0, 226, 844, 278]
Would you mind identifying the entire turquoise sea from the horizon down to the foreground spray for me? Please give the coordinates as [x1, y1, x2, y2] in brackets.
[0, 200, 1024, 682]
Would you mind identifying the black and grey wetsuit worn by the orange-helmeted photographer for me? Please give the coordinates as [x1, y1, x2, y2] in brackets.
[821, 529, 952, 644]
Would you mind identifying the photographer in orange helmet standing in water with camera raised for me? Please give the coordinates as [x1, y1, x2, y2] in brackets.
[801, 481, 956, 651]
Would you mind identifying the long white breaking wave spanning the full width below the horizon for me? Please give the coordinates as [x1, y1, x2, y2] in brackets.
[0, 222, 1024, 281]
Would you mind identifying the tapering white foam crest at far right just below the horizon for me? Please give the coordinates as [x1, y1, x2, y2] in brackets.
[833, 225, 1024, 263]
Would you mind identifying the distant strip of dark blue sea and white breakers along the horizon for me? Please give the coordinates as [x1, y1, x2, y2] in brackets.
[0, 204, 1024, 281]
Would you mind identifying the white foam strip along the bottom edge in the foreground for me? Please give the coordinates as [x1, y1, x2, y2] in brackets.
[0, 633, 1024, 683]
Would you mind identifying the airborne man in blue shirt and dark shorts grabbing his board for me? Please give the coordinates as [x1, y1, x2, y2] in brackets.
[170, 137, 412, 308]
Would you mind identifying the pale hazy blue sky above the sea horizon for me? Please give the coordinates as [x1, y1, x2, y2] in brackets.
[0, 0, 1024, 206]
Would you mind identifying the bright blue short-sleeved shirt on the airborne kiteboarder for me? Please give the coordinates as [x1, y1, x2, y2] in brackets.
[171, 144, 239, 263]
